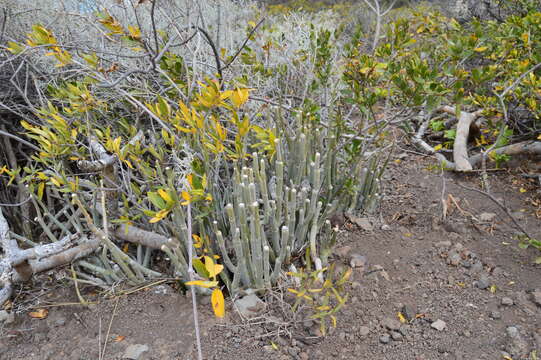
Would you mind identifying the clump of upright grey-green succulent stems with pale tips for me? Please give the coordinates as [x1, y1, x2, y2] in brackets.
[154, 125, 382, 294]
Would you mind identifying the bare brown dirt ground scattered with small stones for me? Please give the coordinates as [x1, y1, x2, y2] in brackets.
[0, 152, 541, 360]
